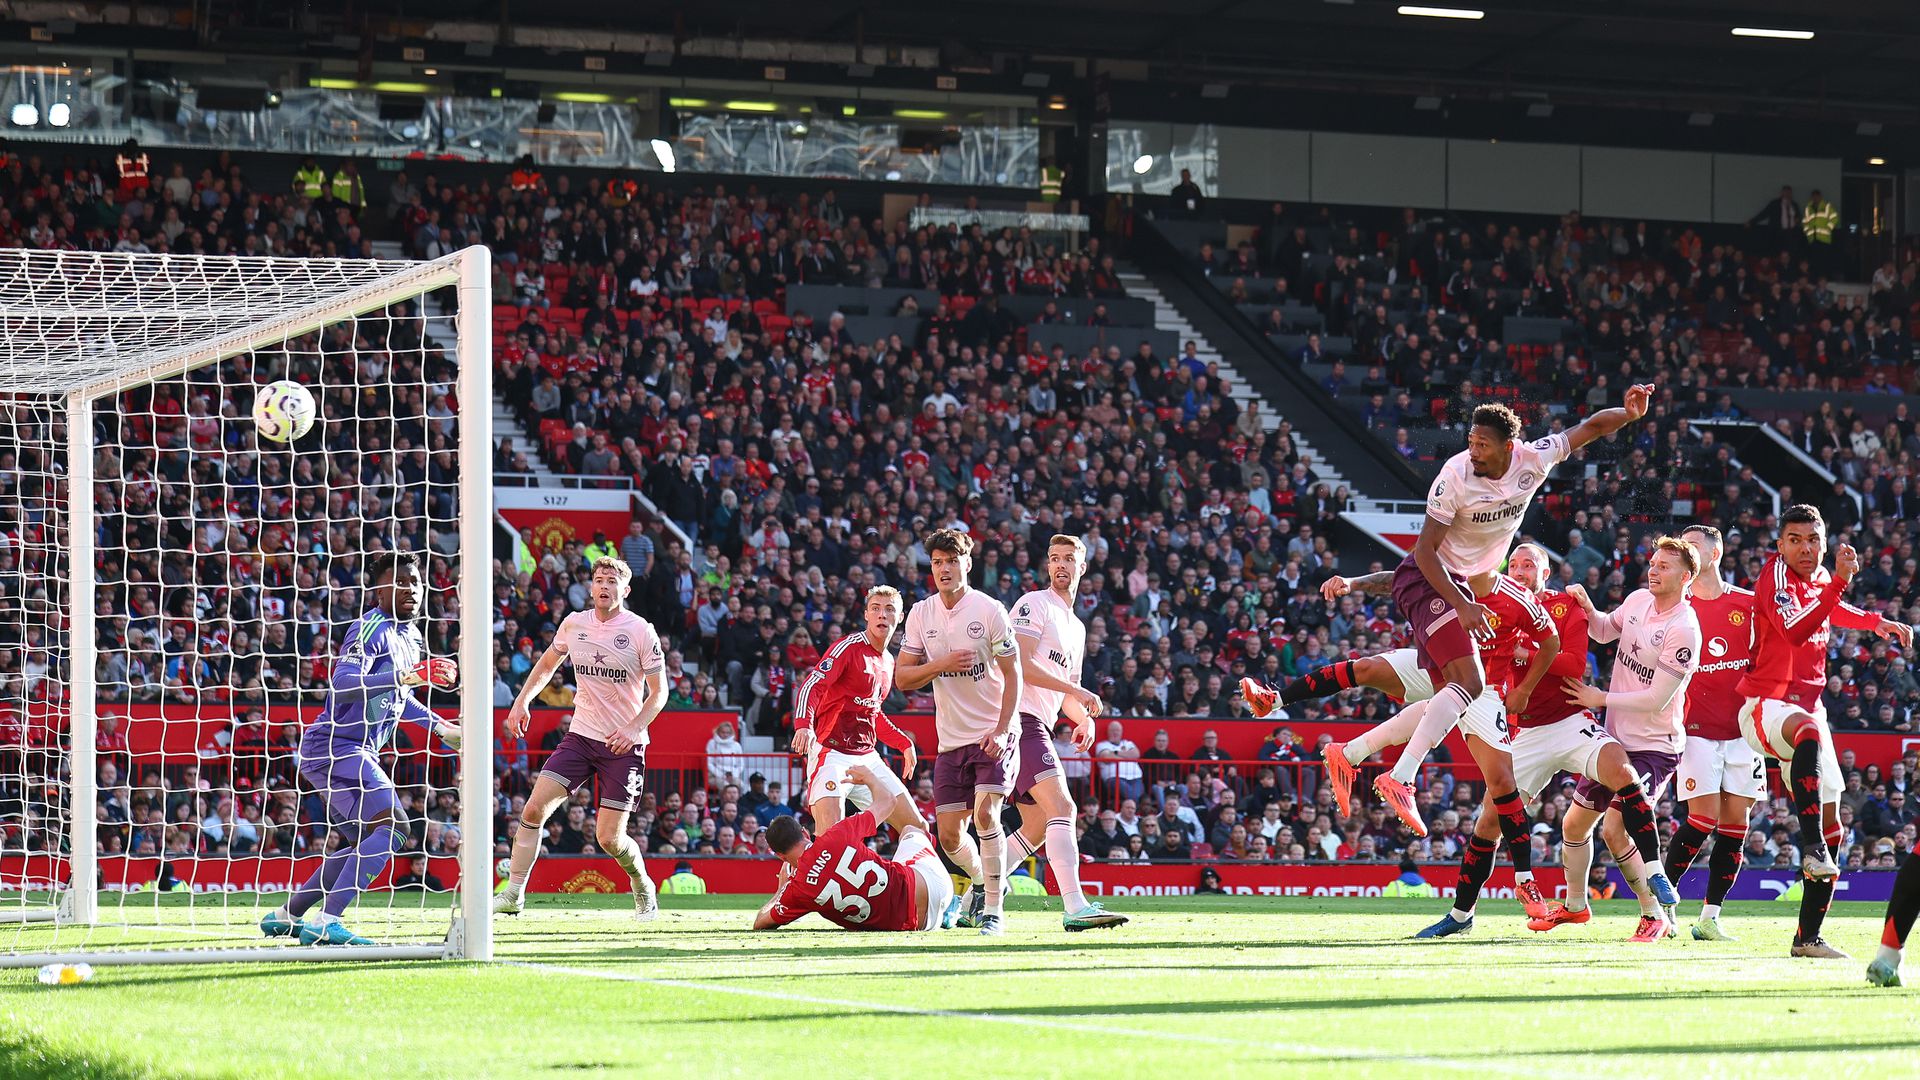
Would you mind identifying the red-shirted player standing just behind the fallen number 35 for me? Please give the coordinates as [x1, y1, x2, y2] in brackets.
[793, 584, 916, 832]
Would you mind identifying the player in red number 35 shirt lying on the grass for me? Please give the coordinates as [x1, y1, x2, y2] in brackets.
[753, 765, 954, 930]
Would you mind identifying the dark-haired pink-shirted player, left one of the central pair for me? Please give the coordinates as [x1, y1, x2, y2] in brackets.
[893, 528, 1021, 934]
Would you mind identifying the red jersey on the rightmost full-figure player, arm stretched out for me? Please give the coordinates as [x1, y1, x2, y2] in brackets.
[1740, 555, 1880, 709]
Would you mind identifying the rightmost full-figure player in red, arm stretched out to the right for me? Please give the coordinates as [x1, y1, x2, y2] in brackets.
[1740, 503, 1914, 959]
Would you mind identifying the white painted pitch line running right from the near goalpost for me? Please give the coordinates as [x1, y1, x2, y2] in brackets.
[501, 961, 1540, 1078]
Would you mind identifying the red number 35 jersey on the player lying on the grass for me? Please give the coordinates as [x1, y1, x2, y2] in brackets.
[772, 811, 920, 930]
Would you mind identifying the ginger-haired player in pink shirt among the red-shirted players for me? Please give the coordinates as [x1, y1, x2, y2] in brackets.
[1530, 536, 1701, 942]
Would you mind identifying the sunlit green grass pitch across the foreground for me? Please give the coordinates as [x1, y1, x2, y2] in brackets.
[0, 897, 1920, 1080]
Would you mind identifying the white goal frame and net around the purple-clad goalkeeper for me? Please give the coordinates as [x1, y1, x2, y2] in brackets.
[0, 248, 493, 967]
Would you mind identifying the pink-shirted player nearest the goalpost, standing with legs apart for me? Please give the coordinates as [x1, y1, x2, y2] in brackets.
[493, 557, 666, 922]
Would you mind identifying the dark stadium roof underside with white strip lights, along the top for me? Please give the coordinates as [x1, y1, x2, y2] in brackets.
[361, 0, 1920, 110]
